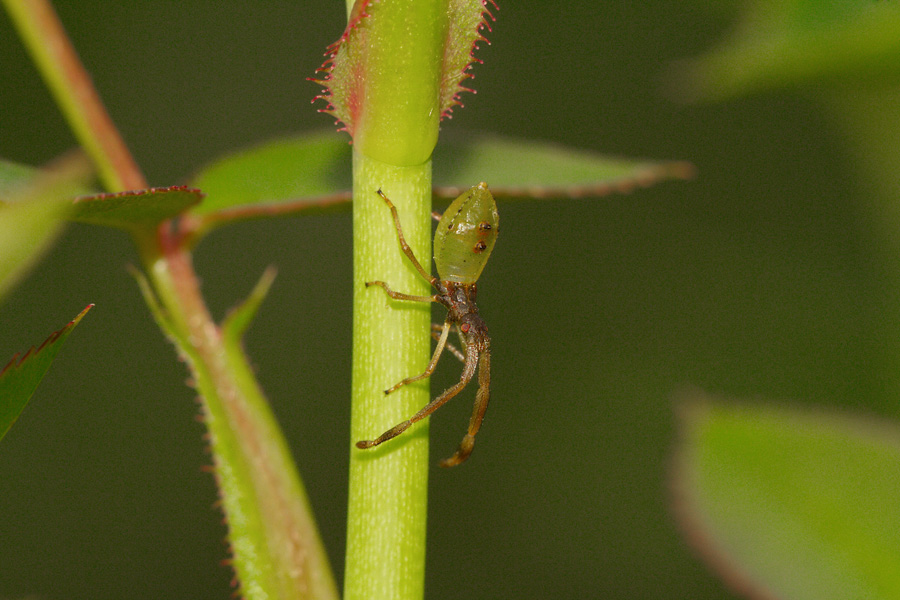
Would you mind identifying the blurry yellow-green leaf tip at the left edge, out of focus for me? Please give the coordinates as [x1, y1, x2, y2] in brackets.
[0, 157, 90, 298]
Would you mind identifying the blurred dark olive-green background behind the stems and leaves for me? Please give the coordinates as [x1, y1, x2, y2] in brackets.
[0, 0, 898, 600]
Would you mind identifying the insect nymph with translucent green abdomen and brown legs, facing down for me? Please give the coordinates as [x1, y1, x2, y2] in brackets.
[356, 182, 500, 467]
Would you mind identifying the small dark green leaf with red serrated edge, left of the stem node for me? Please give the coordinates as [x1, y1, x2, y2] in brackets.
[72, 186, 203, 230]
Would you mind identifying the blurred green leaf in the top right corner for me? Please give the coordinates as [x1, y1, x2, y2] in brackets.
[672, 0, 900, 100]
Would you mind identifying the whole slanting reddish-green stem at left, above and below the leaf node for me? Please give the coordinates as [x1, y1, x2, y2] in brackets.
[3, 0, 337, 600]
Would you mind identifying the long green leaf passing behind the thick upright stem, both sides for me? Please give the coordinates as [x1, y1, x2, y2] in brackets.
[190, 132, 693, 230]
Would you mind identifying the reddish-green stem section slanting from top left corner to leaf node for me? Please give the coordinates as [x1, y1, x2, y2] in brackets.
[3, 0, 147, 192]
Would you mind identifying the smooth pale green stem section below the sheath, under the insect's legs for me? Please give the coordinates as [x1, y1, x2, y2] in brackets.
[344, 152, 431, 600]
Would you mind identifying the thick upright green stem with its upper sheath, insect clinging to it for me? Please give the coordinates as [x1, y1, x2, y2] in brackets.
[329, 0, 449, 600]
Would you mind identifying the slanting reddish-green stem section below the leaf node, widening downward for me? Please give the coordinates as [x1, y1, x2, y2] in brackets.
[140, 233, 337, 600]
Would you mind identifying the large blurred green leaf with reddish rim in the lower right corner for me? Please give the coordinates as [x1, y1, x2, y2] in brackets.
[674, 395, 900, 600]
